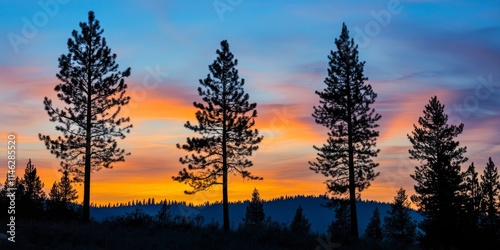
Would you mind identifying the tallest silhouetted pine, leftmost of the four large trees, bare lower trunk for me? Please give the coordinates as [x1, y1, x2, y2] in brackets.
[39, 11, 132, 221]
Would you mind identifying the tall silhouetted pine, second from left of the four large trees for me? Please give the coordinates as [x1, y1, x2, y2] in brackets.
[172, 40, 263, 231]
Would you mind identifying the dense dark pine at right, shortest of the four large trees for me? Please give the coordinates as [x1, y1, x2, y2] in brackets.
[408, 96, 467, 246]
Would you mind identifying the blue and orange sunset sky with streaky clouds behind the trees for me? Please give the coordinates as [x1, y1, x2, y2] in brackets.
[0, 0, 500, 207]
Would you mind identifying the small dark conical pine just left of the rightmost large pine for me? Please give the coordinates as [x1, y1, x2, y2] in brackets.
[383, 188, 417, 244]
